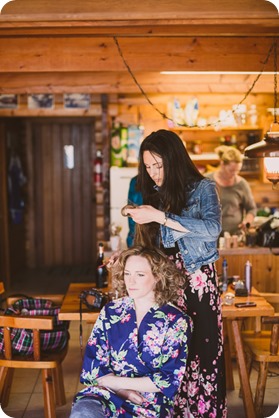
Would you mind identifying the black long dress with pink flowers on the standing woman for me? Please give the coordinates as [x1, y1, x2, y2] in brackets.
[168, 251, 227, 418]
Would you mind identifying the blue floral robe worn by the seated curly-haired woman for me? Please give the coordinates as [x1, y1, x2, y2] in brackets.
[74, 297, 192, 418]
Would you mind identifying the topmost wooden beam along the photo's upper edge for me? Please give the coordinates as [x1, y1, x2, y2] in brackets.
[2, 0, 277, 21]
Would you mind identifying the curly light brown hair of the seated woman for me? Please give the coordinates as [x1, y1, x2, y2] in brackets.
[111, 246, 186, 306]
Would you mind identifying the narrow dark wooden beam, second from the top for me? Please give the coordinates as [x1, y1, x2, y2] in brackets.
[0, 21, 279, 38]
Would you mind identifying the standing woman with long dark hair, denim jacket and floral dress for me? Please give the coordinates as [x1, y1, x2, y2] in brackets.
[122, 129, 227, 418]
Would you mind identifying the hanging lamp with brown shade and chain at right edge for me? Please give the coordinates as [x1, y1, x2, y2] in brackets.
[244, 40, 279, 190]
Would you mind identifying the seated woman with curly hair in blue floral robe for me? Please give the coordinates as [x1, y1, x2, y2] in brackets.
[71, 247, 192, 418]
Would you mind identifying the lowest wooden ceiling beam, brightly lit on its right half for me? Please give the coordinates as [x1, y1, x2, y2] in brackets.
[0, 71, 274, 94]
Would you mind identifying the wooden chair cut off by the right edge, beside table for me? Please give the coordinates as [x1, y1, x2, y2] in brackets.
[242, 293, 279, 418]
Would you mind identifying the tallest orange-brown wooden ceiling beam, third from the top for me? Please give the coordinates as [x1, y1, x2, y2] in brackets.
[0, 36, 273, 74]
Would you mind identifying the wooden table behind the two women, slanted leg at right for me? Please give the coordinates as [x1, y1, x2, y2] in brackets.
[59, 283, 274, 418]
